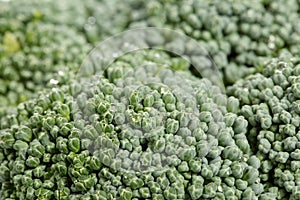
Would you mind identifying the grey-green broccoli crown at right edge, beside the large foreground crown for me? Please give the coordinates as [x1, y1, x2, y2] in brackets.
[228, 56, 300, 199]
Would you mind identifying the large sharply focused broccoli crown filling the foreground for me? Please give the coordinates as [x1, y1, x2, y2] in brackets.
[0, 51, 263, 199]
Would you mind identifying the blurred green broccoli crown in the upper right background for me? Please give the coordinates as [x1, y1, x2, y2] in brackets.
[130, 0, 300, 84]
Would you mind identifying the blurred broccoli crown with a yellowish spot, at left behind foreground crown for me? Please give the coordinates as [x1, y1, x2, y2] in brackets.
[0, 23, 90, 107]
